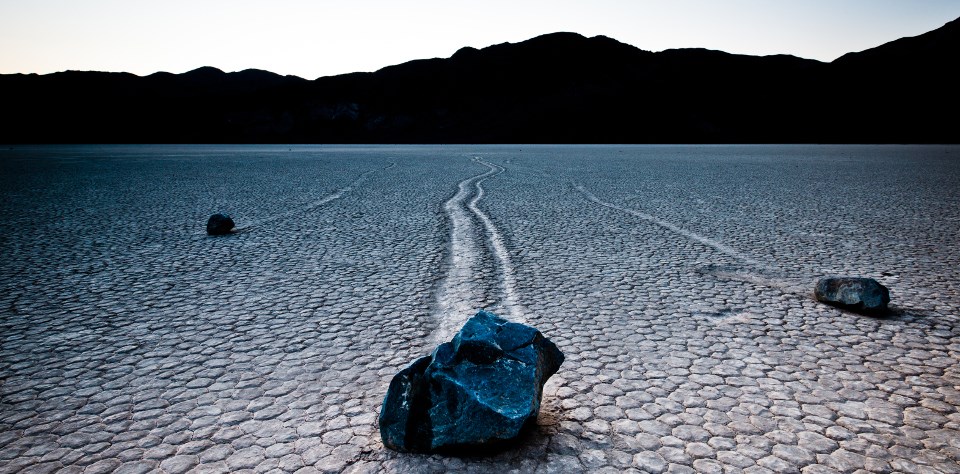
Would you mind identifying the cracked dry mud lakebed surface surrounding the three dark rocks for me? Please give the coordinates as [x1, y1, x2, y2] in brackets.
[0, 146, 960, 473]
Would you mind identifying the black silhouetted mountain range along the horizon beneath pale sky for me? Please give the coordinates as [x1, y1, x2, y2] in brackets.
[0, 20, 960, 143]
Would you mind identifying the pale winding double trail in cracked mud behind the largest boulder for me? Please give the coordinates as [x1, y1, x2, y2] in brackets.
[434, 158, 524, 341]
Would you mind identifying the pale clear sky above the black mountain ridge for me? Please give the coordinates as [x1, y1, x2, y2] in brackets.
[0, 0, 960, 79]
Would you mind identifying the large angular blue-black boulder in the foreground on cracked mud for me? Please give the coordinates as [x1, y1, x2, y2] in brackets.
[380, 311, 563, 452]
